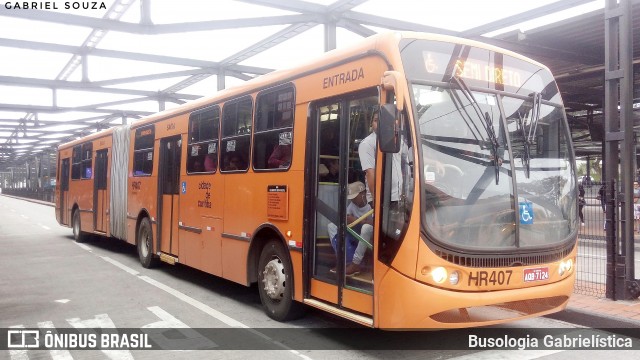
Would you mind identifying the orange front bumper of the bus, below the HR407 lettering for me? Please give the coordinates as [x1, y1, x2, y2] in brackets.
[374, 269, 575, 329]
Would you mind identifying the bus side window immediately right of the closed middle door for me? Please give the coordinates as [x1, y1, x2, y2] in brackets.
[187, 106, 220, 174]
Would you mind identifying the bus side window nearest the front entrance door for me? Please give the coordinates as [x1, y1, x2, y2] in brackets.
[253, 86, 295, 170]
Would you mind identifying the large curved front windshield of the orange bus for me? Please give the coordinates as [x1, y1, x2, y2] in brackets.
[403, 41, 577, 253]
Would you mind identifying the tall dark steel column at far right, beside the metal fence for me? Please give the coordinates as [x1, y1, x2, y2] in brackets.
[604, 0, 640, 300]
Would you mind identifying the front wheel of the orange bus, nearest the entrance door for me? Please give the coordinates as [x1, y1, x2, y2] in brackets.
[258, 240, 304, 321]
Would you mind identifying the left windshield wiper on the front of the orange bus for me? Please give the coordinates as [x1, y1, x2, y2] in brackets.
[451, 76, 501, 185]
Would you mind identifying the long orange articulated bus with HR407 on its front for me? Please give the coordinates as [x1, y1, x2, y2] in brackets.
[56, 33, 577, 329]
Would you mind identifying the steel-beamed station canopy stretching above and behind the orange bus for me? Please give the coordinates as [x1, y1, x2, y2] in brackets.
[0, 0, 640, 171]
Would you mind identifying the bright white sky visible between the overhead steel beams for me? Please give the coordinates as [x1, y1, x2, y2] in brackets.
[0, 0, 604, 150]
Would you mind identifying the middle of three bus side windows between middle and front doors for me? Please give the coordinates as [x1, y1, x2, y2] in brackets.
[220, 97, 252, 171]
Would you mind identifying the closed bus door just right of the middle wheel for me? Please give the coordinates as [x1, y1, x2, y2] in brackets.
[157, 135, 182, 256]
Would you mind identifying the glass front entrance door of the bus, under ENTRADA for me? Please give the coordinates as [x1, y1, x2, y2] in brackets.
[308, 89, 378, 315]
